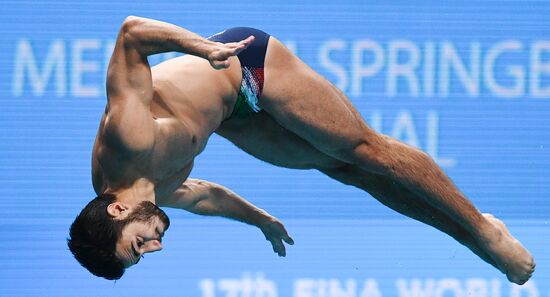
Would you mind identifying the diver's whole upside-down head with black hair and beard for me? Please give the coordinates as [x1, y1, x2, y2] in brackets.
[67, 194, 170, 280]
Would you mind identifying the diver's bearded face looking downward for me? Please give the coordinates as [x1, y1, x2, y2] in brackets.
[115, 202, 170, 268]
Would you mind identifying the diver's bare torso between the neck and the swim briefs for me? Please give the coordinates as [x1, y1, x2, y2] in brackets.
[92, 55, 241, 199]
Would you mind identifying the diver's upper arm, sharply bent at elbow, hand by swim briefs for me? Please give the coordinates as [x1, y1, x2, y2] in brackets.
[105, 16, 254, 151]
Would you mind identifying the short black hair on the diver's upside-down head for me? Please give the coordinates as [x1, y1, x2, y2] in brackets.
[67, 194, 128, 280]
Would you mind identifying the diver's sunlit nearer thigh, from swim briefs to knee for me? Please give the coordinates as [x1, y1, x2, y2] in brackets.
[259, 38, 378, 156]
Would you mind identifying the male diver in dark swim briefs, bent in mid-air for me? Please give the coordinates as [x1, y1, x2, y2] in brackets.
[68, 16, 535, 284]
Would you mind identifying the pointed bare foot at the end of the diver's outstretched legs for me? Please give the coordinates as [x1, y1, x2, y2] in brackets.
[480, 214, 535, 285]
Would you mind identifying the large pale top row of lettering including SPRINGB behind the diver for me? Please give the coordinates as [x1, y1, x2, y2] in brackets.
[11, 38, 550, 98]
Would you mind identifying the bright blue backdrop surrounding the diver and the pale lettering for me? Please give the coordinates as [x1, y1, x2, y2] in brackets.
[0, 0, 550, 297]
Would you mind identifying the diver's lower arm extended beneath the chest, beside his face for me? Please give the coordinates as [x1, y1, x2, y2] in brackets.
[159, 179, 294, 256]
